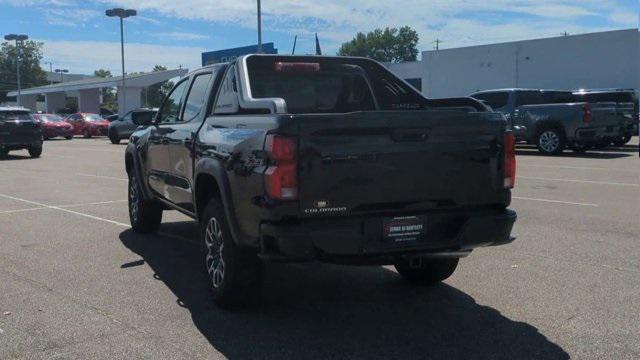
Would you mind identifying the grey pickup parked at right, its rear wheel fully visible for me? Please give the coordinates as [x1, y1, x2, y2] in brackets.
[471, 89, 625, 155]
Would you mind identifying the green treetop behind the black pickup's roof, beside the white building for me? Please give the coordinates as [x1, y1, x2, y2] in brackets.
[338, 26, 419, 63]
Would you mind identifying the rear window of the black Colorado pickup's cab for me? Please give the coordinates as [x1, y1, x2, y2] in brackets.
[247, 56, 426, 114]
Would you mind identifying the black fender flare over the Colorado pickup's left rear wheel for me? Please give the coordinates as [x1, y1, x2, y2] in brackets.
[193, 158, 248, 245]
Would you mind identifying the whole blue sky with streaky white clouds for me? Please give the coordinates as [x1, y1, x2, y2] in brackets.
[0, 0, 639, 74]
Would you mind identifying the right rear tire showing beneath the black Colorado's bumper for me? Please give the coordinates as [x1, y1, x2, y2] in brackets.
[395, 258, 460, 285]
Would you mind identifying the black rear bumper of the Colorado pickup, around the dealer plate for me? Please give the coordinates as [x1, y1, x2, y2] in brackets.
[260, 209, 517, 264]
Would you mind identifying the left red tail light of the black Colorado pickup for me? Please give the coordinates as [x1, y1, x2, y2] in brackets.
[265, 135, 298, 200]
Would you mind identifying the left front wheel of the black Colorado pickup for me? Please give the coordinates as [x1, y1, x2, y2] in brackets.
[128, 174, 162, 234]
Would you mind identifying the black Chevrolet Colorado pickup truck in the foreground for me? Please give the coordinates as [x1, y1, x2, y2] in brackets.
[125, 55, 516, 306]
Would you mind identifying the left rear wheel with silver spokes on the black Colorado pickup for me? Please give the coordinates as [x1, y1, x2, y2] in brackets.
[200, 199, 262, 309]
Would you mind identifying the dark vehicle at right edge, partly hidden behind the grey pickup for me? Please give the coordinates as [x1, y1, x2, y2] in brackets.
[573, 89, 640, 146]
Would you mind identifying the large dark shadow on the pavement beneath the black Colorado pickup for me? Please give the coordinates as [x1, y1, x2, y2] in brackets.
[120, 222, 568, 359]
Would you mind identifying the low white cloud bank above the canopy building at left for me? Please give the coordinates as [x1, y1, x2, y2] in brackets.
[39, 39, 204, 74]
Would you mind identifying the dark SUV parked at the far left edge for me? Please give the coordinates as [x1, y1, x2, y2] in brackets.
[0, 107, 42, 158]
